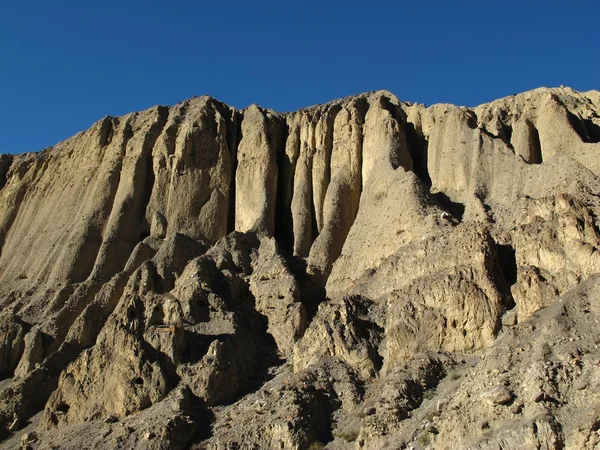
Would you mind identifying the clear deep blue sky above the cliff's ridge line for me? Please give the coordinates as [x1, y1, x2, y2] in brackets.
[0, 0, 600, 153]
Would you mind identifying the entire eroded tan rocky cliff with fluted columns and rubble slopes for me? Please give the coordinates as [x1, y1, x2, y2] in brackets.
[0, 88, 600, 450]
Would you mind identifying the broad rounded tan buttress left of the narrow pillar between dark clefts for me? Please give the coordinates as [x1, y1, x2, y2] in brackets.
[146, 97, 239, 242]
